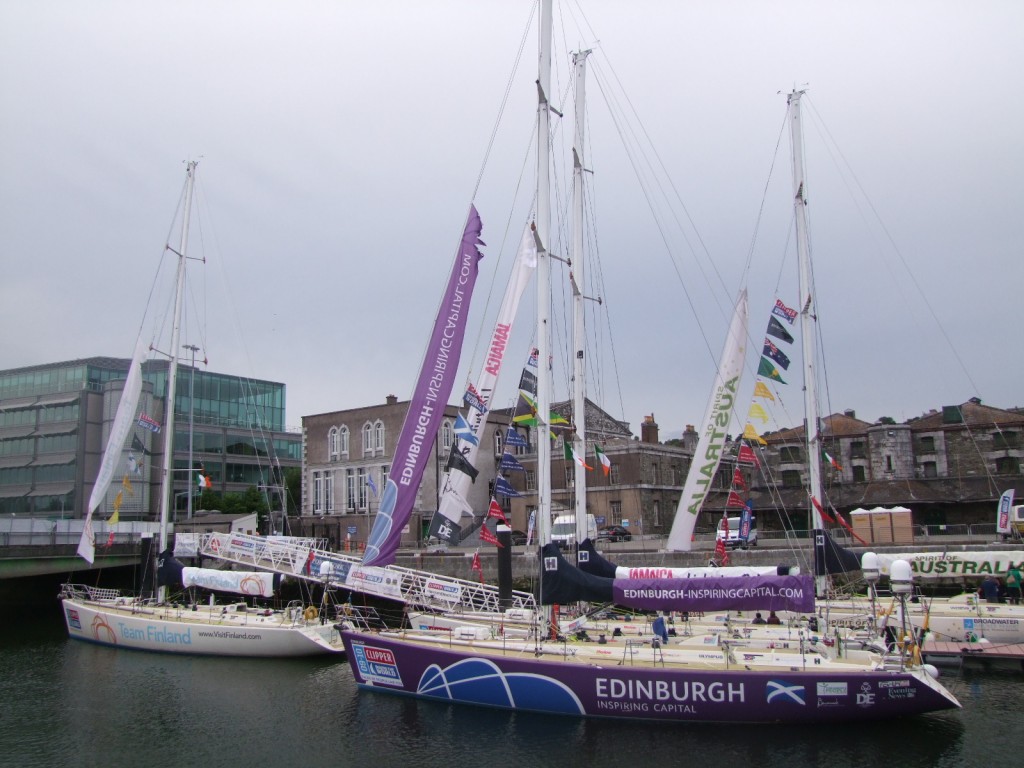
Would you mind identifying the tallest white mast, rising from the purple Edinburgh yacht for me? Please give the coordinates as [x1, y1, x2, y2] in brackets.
[537, 0, 551, 546]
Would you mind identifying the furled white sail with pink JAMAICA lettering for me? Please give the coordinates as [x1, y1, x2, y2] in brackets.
[430, 227, 537, 544]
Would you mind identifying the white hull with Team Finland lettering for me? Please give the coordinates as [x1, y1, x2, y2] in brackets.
[61, 598, 344, 657]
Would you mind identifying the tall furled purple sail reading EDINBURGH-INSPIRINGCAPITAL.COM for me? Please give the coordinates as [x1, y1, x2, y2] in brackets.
[362, 206, 483, 565]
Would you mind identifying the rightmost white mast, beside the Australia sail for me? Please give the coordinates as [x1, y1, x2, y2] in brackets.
[788, 90, 827, 597]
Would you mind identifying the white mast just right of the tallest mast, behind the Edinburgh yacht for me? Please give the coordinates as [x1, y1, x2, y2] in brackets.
[568, 50, 590, 557]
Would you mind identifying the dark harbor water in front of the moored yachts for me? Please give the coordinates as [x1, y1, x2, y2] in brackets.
[0, 600, 1024, 768]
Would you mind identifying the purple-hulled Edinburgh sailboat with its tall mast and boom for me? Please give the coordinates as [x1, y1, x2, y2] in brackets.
[342, 2, 959, 723]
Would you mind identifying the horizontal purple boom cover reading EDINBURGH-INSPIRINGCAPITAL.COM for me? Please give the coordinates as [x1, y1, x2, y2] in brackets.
[613, 574, 814, 613]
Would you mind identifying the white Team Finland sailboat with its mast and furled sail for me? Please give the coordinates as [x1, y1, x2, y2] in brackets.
[60, 162, 343, 656]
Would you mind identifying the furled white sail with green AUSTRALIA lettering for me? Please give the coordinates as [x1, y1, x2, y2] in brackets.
[666, 289, 746, 552]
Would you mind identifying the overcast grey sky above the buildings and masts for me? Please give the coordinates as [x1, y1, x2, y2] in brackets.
[0, 0, 1024, 435]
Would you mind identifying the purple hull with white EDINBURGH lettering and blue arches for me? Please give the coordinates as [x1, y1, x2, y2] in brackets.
[342, 630, 959, 723]
